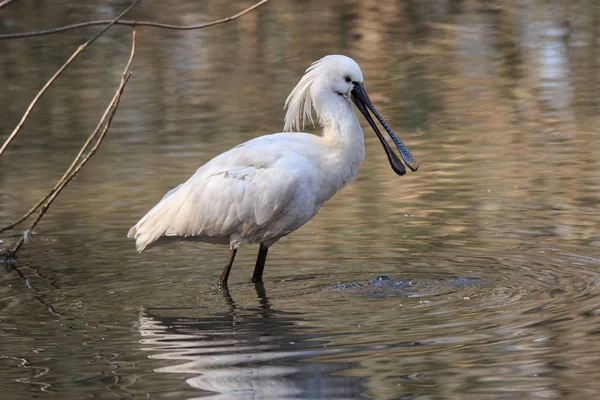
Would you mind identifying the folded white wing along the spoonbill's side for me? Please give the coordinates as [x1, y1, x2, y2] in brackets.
[129, 165, 297, 251]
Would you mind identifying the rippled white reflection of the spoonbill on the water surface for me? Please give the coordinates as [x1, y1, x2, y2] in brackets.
[140, 283, 365, 399]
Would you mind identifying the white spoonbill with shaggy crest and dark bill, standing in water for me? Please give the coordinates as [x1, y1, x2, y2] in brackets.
[127, 55, 419, 286]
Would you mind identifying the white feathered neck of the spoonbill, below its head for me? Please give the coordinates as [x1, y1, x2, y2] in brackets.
[313, 93, 365, 202]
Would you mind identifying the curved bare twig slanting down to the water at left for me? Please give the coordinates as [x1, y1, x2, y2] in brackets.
[8, 30, 135, 257]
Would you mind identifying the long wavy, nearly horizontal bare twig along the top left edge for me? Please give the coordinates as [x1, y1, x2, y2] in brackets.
[0, 0, 270, 40]
